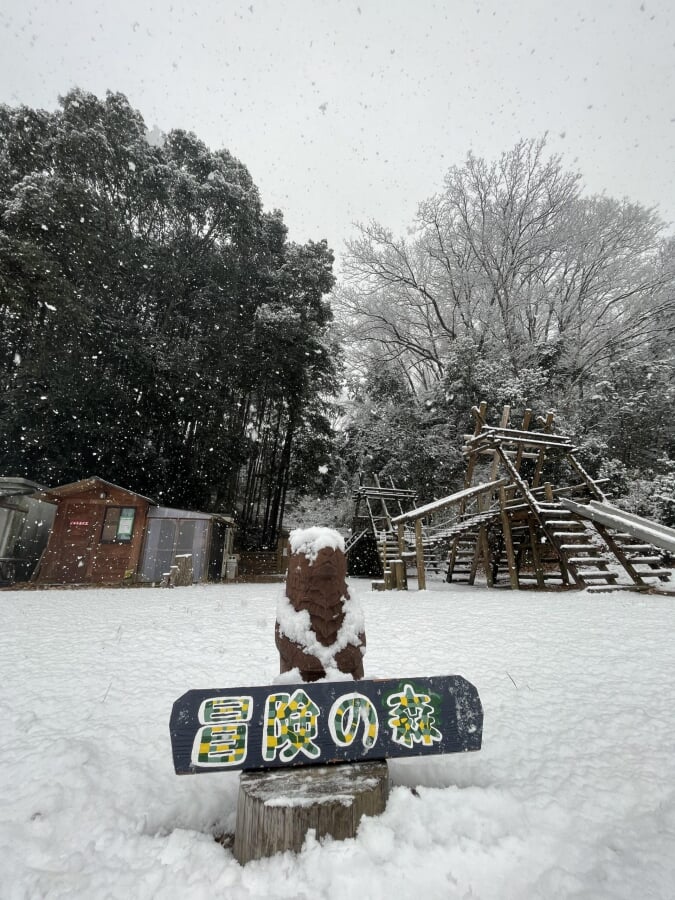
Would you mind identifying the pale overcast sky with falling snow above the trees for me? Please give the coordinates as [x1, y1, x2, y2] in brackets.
[0, 0, 675, 251]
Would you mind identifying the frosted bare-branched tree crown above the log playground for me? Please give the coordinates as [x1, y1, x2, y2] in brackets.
[339, 140, 673, 404]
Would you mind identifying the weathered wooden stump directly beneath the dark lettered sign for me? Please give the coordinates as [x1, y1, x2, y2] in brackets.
[233, 760, 389, 865]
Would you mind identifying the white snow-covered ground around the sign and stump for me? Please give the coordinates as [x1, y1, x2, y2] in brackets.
[0, 580, 675, 900]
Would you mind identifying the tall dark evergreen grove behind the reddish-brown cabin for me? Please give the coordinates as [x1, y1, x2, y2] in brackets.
[0, 90, 334, 542]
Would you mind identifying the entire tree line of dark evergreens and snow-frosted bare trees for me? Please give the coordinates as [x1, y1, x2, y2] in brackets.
[0, 90, 675, 547]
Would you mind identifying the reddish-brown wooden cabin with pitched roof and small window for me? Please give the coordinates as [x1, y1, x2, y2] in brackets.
[35, 478, 157, 584]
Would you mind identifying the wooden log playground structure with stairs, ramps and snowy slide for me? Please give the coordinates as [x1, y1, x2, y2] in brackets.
[347, 403, 675, 591]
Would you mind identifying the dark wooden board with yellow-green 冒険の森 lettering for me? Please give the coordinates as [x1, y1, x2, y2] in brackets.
[170, 675, 483, 775]
